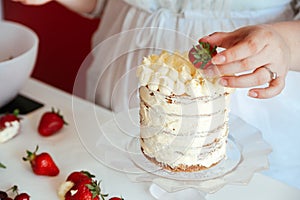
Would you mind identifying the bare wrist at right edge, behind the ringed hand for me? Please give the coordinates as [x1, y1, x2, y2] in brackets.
[271, 20, 300, 71]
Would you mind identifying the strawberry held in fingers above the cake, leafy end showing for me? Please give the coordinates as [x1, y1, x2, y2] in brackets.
[189, 41, 217, 69]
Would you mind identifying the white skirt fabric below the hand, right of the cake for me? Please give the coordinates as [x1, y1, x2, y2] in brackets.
[231, 71, 300, 189]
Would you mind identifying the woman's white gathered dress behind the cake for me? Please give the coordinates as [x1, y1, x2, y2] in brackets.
[79, 0, 300, 191]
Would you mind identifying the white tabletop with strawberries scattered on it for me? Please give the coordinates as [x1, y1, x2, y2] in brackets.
[0, 79, 300, 200]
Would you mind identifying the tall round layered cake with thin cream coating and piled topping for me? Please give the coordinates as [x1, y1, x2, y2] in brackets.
[136, 51, 231, 172]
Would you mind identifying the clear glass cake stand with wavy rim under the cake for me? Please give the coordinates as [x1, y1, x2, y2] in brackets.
[77, 108, 272, 197]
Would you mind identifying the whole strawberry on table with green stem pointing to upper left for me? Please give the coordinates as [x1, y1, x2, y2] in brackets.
[23, 146, 59, 176]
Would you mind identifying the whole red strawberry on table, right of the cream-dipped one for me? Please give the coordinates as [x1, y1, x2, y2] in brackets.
[38, 108, 67, 136]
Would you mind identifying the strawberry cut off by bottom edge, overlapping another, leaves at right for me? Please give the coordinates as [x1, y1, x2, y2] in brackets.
[65, 181, 108, 200]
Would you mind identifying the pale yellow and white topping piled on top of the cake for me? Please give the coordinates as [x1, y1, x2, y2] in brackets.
[137, 51, 231, 97]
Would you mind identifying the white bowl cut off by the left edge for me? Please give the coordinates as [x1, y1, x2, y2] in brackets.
[0, 21, 39, 107]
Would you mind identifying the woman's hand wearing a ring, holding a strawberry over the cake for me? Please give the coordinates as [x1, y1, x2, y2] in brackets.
[200, 25, 291, 98]
